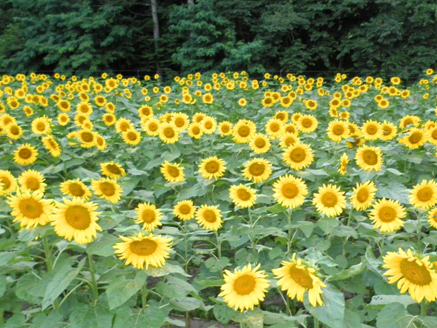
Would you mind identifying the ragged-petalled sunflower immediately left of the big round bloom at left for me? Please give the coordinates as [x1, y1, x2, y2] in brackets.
[7, 191, 53, 229]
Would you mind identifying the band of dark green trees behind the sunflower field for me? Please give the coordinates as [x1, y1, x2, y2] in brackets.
[0, 0, 437, 79]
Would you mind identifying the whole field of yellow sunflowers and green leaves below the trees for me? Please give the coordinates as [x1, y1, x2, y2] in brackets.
[0, 69, 437, 328]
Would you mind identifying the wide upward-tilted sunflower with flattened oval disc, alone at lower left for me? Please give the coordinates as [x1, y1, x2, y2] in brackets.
[114, 232, 173, 270]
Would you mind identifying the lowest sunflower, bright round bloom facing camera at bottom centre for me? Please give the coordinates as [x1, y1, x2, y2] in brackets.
[218, 264, 270, 312]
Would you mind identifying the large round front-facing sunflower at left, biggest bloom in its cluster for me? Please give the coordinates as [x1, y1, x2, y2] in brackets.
[51, 197, 102, 244]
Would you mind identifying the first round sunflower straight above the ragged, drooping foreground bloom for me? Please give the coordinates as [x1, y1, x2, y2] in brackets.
[273, 174, 308, 208]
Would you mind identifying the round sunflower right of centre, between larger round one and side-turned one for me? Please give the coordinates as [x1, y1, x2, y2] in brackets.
[313, 184, 346, 217]
